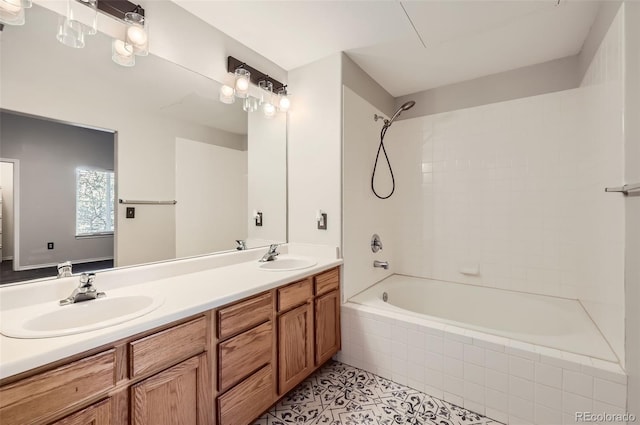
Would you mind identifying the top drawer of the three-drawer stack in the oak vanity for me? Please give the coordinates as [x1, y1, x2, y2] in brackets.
[218, 292, 273, 339]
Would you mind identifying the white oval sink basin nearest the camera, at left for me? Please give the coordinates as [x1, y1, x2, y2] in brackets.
[0, 294, 164, 338]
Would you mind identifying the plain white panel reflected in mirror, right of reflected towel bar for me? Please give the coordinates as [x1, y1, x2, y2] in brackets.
[176, 137, 249, 257]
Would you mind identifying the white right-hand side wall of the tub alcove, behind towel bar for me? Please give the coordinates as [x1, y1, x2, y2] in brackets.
[578, 3, 624, 366]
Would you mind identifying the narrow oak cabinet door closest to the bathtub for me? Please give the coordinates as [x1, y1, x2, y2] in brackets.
[315, 291, 340, 366]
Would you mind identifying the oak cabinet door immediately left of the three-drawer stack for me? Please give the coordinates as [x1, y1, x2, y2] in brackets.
[131, 354, 213, 425]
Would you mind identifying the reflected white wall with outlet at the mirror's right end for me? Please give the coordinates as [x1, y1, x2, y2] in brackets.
[248, 113, 287, 248]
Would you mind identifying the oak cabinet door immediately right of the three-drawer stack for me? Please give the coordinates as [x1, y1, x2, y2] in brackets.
[278, 302, 313, 395]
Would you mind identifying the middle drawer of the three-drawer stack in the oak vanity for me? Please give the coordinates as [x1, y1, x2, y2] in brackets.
[218, 322, 273, 392]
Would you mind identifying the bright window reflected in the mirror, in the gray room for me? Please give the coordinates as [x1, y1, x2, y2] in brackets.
[76, 168, 115, 236]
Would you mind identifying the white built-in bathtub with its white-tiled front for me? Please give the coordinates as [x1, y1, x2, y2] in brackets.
[338, 274, 627, 425]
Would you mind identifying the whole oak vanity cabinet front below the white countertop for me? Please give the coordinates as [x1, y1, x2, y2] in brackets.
[0, 267, 340, 425]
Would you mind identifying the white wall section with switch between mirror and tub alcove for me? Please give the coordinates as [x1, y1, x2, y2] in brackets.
[288, 54, 342, 247]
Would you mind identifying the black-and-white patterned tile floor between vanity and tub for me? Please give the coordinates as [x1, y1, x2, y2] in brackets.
[253, 362, 500, 425]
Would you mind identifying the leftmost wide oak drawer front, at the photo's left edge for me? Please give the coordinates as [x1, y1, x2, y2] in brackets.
[0, 350, 116, 425]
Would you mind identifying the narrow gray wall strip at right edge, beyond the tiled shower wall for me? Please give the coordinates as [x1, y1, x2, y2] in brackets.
[624, 1, 640, 417]
